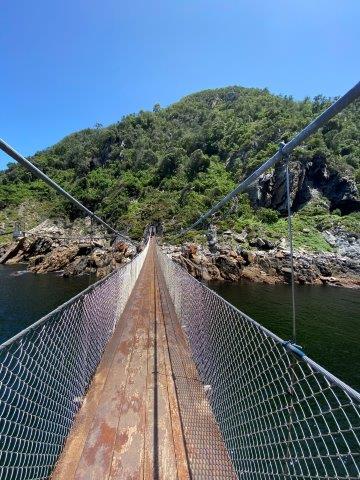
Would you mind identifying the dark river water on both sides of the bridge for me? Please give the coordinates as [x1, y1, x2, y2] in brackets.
[0, 265, 360, 389]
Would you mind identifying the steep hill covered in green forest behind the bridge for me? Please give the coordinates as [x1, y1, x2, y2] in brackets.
[0, 87, 360, 248]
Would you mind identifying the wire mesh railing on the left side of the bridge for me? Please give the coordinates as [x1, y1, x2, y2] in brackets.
[0, 247, 147, 480]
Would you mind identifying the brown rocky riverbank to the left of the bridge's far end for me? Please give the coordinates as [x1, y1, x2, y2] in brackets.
[0, 219, 136, 278]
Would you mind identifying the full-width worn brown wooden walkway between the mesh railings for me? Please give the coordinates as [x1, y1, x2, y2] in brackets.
[52, 242, 236, 480]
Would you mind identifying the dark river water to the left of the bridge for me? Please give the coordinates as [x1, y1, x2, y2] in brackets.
[0, 265, 93, 343]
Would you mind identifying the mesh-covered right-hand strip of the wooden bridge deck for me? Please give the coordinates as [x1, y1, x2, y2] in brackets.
[158, 262, 237, 480]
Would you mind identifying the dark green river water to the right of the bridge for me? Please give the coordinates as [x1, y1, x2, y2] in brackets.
[209, 282, 360, 390]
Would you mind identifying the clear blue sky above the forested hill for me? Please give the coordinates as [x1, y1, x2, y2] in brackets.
[0, 0, 360, 168]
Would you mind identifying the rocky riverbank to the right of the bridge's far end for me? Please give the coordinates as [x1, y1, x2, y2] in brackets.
[163, 227, 360, 288]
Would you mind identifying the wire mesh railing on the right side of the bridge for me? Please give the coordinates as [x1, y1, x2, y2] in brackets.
[157, 247, 360, 480]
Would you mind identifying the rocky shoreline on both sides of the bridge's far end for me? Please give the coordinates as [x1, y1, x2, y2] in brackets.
[0, 220, 360, 288]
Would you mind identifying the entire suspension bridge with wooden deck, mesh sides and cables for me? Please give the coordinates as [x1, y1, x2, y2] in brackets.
[0, 83, 360, 480]
